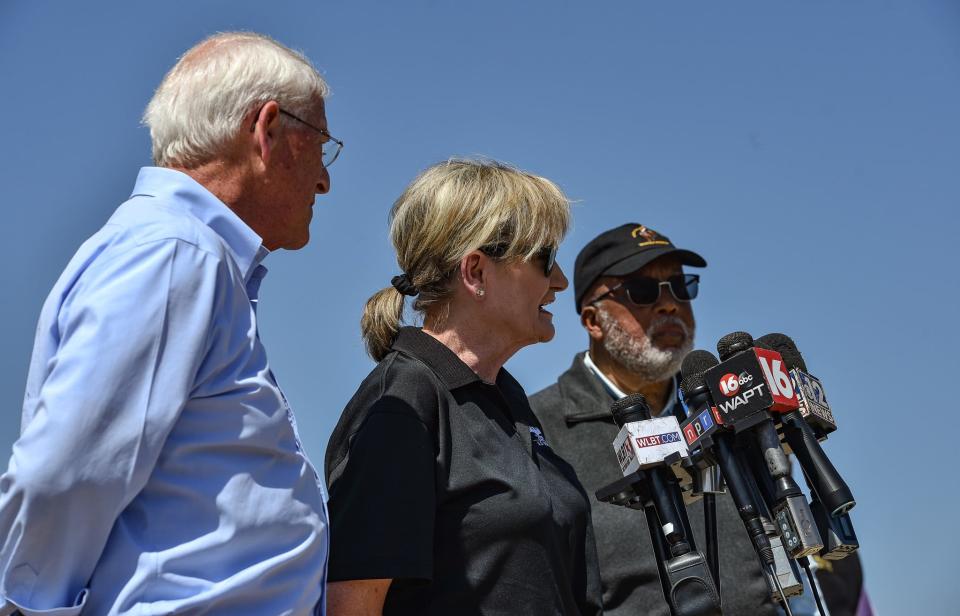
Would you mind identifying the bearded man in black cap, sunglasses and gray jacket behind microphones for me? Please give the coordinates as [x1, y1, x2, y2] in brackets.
[530, 223, 780, 616]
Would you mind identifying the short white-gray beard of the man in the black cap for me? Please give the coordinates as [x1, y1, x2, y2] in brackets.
[597, 306, 694, 383]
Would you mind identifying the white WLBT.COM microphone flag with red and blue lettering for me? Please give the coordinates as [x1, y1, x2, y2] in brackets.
[613, 415, 690, 476]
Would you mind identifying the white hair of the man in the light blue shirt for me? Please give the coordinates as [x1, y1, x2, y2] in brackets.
[143, 32, 329, 168]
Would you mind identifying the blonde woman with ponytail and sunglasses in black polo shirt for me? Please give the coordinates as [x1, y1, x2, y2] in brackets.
[326, 160, 601, 616]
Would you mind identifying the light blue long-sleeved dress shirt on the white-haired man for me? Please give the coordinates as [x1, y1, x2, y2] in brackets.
[0, 167, 328, 616]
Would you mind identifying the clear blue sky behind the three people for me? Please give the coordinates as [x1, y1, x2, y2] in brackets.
[0, 0, 960, 614]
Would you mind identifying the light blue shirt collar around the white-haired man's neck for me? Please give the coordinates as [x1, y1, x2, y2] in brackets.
[131, 167, 270, 280]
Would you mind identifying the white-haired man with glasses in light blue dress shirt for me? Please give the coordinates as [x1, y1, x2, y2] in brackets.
[0, 33, 342, 616]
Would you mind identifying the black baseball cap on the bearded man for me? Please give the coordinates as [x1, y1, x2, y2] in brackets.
[573, 222, 707, 314]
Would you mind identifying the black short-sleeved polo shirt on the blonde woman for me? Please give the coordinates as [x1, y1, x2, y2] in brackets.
[325, 327, 601, 616]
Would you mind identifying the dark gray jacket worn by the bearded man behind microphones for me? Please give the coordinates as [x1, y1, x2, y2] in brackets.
[530, 353, 781, 616]
